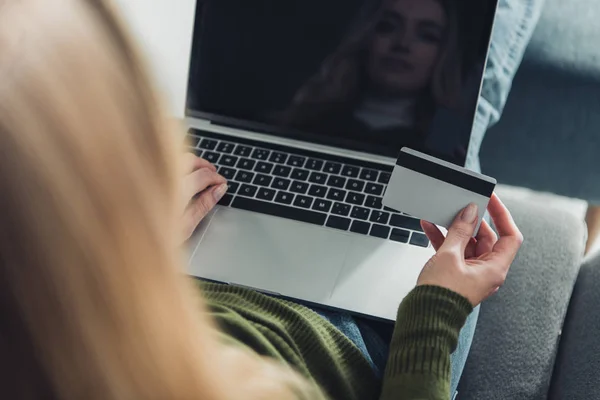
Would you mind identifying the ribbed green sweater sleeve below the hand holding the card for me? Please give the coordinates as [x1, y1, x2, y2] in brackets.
[380, 286, 473, 400]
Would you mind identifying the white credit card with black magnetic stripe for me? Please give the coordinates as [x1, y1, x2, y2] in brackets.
[383, 147, 496, 234]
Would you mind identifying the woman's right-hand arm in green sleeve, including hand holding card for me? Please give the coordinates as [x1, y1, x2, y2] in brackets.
[381, 195, 523, 400]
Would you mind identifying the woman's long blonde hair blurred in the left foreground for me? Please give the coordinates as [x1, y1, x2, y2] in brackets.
[0, 0, 310, 400]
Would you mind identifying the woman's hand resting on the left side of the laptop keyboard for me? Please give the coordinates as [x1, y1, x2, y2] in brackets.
[182, 153, 227, 241]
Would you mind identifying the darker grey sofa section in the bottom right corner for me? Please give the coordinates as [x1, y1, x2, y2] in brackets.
[549, 254, 600, 400]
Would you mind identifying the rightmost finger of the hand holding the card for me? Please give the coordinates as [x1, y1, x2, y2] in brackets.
[488, 194, 523, 265]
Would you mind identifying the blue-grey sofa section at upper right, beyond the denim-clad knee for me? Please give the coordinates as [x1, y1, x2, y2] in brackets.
[480, 0, 600, 203]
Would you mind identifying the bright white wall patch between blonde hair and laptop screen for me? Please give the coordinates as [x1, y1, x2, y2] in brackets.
[114, 0, 196, 117]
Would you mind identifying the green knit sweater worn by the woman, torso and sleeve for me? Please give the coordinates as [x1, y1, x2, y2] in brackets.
[200, 283, 472, 400]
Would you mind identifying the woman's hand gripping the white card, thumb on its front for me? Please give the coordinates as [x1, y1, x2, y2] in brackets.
[417, 194, 523, 306]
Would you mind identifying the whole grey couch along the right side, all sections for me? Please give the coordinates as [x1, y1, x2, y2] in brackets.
[458, 0, 600, 400]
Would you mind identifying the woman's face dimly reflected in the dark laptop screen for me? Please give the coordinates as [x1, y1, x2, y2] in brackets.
[367, 0, 447, 95]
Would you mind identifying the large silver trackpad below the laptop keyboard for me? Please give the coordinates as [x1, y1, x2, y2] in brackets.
[190, 208, 352, 303]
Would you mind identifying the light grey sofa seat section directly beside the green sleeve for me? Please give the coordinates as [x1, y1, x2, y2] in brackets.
[458, 193, 586, 400]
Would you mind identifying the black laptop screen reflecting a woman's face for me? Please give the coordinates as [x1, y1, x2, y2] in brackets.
[187, 0, 497, 165]
